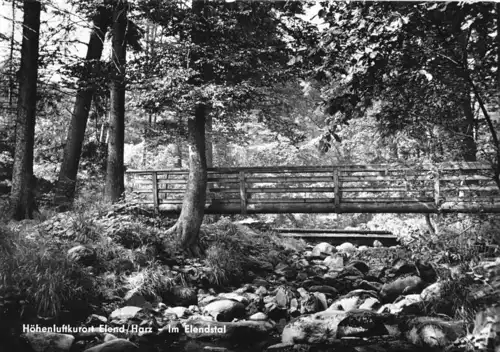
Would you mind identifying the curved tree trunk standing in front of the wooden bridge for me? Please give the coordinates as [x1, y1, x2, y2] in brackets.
[168, 105, 207, 256]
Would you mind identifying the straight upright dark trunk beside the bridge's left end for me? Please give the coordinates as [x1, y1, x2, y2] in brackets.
[104, 0, 128, 203]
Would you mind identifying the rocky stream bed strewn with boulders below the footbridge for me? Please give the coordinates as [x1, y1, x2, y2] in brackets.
[3, 231, 486, 352]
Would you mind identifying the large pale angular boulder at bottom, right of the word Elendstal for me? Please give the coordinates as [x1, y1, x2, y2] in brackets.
[281, 310, 347, 344]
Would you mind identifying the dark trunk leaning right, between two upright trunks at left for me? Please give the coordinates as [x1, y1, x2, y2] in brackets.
[54, 7, 110, 209]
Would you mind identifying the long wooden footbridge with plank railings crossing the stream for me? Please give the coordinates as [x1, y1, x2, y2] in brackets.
[127, 162, 500, 214]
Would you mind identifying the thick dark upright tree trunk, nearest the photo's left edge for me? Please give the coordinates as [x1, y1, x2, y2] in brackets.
[11, 0, 41, 220]
